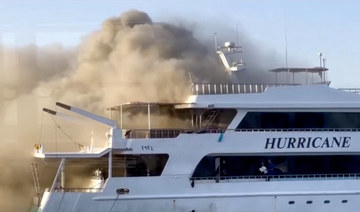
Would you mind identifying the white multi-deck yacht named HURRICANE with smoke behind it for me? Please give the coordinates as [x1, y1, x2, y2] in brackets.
[34, 42, 360, 212]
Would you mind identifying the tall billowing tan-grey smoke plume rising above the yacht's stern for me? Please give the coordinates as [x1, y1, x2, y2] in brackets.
[41, 11, 227, 111]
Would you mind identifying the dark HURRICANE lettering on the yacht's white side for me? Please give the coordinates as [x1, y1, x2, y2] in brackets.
[265, 136, 351, 149]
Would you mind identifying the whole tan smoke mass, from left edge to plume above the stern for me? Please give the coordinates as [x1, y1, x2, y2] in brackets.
[0, 10, 286, 212]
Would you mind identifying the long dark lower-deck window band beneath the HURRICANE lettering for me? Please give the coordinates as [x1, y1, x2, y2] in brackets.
[192, 154, 360, 178]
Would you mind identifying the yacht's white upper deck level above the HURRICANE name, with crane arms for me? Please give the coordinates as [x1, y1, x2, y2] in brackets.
[38, 83, 360, 152]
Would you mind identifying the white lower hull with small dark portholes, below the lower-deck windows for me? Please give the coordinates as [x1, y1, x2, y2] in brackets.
[39, 177, 360, 212]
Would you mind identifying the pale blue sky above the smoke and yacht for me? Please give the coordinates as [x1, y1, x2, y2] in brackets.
[0, 0, 360, 88]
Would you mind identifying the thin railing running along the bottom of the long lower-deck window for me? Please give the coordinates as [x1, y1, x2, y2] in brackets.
[190, 173, 360, 183]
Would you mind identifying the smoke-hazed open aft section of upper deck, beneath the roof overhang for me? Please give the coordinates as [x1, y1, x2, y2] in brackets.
[110, 103, 237, 129]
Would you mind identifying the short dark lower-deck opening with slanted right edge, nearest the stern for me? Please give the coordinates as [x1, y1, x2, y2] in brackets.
[112, 153, 169, 177]
